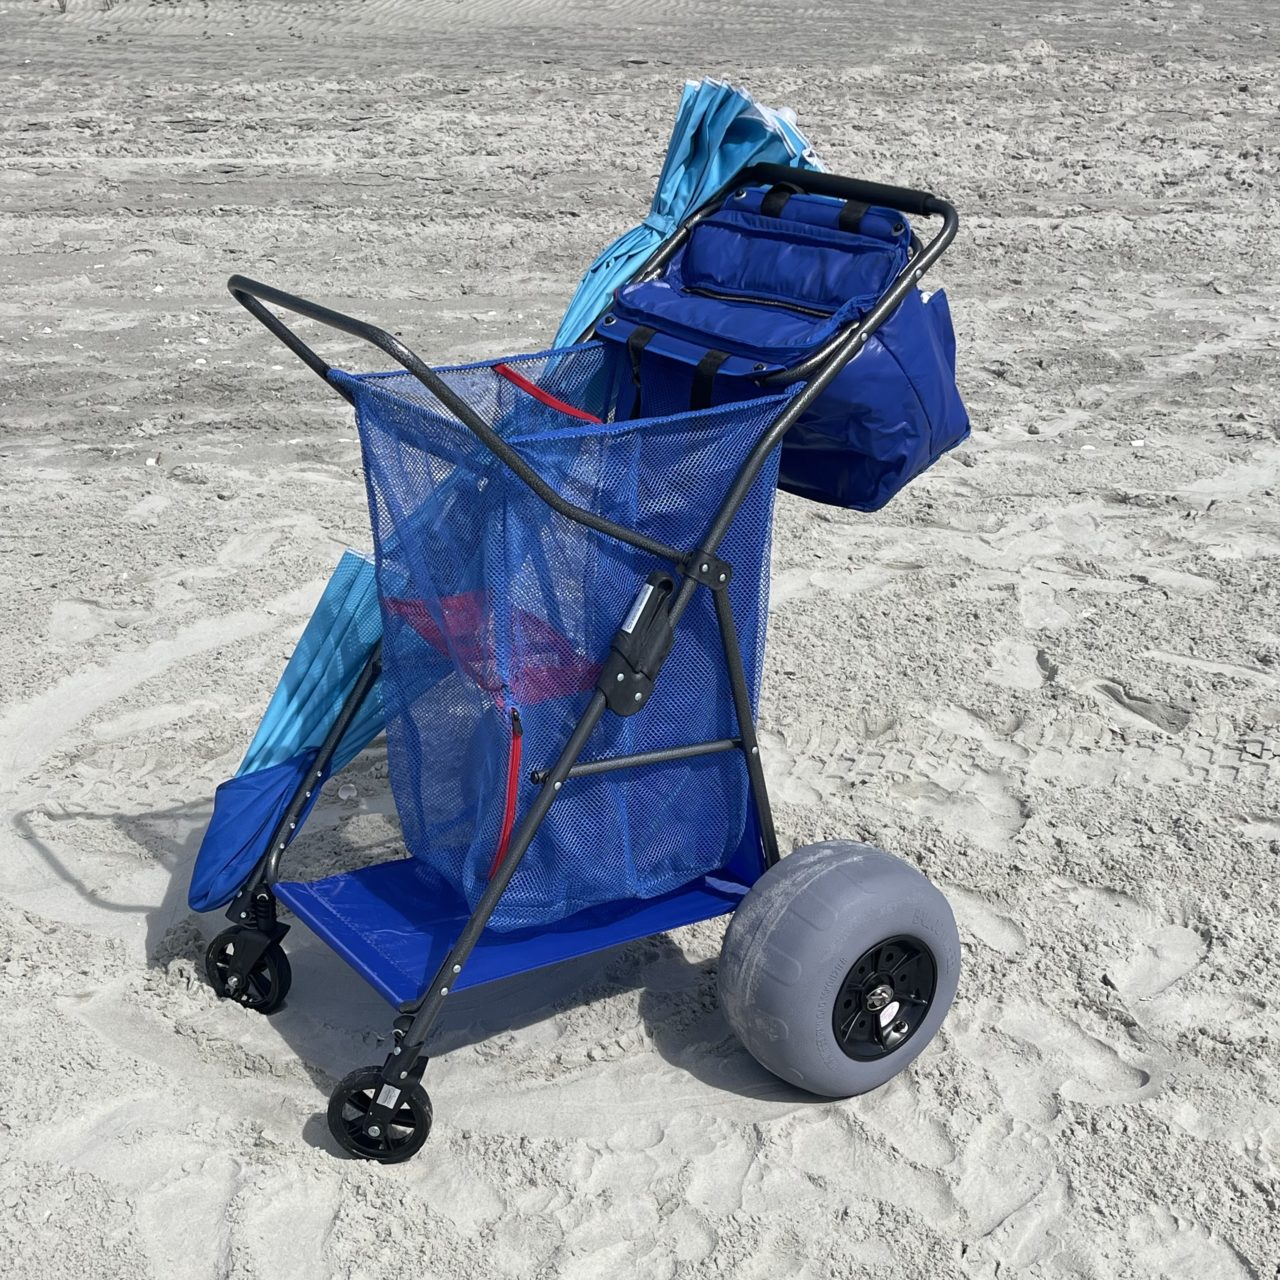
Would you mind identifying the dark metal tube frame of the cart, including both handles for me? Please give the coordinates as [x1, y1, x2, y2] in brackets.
[227, 165, 959, 1146]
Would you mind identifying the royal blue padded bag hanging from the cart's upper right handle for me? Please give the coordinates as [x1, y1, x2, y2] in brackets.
[598, 188, 969, 511]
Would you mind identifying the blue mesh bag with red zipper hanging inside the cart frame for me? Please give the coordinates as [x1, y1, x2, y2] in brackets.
[330, 342, 786, 931]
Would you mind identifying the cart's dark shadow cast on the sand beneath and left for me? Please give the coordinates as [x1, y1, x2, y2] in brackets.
[13, 783, 822, 1153]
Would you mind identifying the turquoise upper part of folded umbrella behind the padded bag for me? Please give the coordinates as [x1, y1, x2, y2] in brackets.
[553, 79, 822, 347]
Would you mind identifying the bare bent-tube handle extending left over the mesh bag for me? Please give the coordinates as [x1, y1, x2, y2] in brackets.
[227, 275, 689, 568]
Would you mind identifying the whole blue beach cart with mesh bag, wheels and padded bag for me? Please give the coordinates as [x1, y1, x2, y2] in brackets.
[192, 165, 968, 1162]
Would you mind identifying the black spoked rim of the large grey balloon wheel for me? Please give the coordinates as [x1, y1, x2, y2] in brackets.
[831, 937, 938, 1062]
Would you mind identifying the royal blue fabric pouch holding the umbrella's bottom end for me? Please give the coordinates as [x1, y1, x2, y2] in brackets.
[187, 751, 328, 911]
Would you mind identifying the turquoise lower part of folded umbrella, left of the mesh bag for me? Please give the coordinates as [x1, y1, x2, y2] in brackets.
[236, 550, 384, 777]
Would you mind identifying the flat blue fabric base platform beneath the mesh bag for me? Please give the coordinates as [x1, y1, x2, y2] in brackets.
[275, 858, 749, 1009]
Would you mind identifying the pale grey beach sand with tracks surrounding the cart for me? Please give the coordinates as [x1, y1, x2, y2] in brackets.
[0, 0, 1280, 1280]
